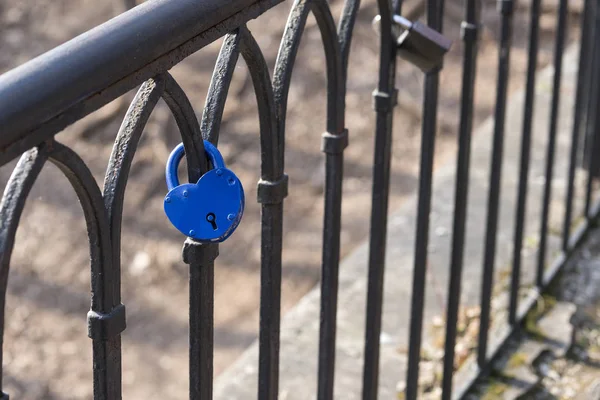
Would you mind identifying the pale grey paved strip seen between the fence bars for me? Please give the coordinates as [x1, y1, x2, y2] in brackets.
[215, 43, 577, 400]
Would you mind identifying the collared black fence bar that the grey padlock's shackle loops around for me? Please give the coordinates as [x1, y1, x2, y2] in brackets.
[362, 0, 402, 400]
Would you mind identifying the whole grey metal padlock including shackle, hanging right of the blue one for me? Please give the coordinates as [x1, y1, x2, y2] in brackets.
[373, 15, 452, 73]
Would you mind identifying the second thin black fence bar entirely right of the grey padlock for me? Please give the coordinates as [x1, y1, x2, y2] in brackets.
[477, 0, 513, 366]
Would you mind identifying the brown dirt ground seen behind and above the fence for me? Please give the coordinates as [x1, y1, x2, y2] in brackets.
[0, 0, 580, 399]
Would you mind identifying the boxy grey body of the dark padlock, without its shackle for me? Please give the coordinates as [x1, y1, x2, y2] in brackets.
[397, 21, 452, 73]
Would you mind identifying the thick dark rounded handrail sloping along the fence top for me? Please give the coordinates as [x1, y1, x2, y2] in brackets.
[0, 0, 283, 165]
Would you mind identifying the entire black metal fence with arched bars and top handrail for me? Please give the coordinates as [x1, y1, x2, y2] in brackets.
[0, 0, 600, 400]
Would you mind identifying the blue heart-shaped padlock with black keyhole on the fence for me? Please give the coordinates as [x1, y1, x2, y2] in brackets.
[164, 140, 244, 243]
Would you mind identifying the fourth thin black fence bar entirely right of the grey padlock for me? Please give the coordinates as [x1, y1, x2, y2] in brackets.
[536, 0, 567, 288]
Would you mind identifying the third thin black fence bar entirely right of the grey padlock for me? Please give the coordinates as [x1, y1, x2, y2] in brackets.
[508, 0, 541, 324]
